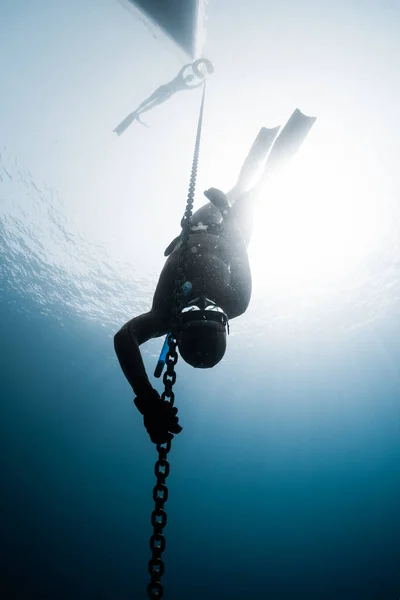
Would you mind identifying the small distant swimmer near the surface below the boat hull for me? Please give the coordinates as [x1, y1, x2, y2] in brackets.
[114, 58, 214, 136]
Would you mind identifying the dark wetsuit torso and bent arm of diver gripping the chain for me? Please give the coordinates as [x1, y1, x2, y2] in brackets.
[114, 192, 252, 396]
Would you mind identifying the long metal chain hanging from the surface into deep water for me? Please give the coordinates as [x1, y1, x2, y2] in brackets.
[147, 83, 206, 600]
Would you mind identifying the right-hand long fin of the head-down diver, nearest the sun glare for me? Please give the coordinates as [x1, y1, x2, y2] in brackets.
[262, 108, 317, 180]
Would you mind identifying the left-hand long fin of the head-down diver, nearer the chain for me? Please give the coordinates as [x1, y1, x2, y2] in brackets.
[227, 126, 280, 204]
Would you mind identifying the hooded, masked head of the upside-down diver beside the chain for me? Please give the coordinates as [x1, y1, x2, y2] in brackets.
[177, 297, 229, 369]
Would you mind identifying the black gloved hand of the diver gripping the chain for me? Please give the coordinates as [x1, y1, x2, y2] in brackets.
[134, 388, 182, 444]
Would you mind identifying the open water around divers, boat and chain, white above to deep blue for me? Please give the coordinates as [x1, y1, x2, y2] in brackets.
[0, 0, 400, 600]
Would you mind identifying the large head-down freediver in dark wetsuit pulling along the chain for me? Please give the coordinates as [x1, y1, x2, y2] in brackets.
[114, 110, 315, 443]
